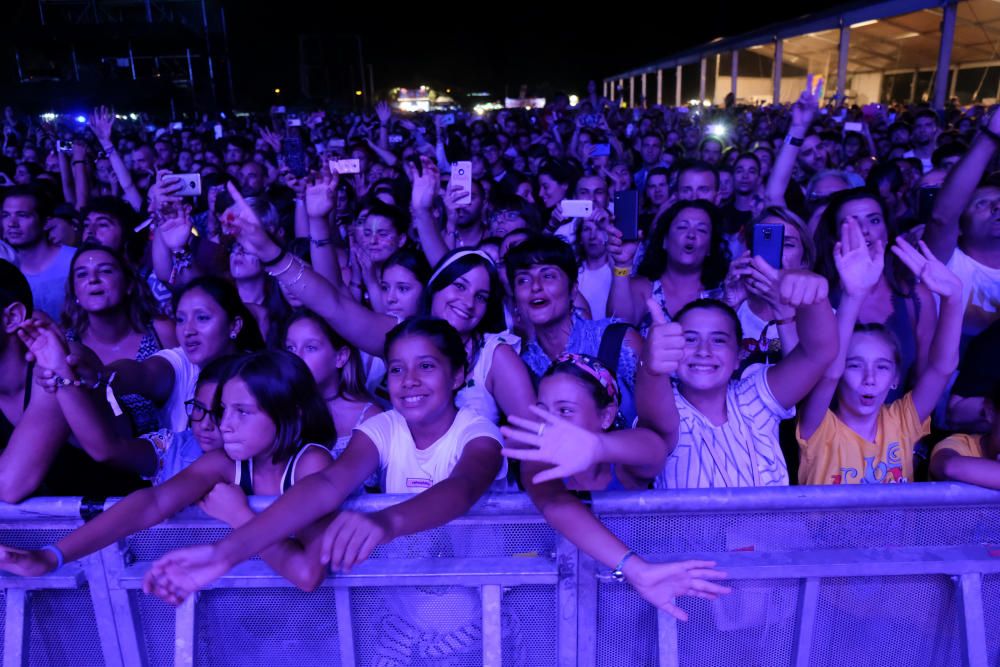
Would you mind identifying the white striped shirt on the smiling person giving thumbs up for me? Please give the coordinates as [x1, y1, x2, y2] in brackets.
[654, 365, 795, 489]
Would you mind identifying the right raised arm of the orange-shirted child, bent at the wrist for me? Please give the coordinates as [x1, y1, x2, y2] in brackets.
[892, 236, 965, 421]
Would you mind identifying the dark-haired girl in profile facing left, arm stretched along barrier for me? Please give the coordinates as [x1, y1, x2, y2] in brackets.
[0, 352, 333, 590]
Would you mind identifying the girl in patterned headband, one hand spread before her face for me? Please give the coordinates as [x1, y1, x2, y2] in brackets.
[501, 353, 729, 628]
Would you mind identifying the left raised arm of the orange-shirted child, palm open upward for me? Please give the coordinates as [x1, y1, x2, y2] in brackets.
[792, 220, 885, 439]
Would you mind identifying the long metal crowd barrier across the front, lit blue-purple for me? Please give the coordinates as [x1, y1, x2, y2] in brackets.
[0, 484, 1000, 667]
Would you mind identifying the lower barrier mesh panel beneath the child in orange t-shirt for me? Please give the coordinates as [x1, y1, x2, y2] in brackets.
[809, 576, 962, 667]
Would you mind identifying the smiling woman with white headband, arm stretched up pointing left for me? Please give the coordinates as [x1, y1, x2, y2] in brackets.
[216, 180, 535, 423]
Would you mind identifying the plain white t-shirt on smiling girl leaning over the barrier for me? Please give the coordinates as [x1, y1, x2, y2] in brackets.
[355, 409, 507, 493]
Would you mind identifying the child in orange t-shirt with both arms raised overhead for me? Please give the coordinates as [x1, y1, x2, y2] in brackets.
[796, 219, 964, 484]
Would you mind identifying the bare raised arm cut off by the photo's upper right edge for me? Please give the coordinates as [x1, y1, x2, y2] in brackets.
[924, 112, 1000, 263]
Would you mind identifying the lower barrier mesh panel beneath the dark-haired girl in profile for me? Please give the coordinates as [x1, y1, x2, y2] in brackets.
[195, 588, 340, 667]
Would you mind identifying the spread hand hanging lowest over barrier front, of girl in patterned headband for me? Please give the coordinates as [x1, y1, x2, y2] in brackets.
[624, 556, 732, 621]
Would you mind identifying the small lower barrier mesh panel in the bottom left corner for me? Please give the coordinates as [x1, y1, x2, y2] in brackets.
[25, 588, 104, 667]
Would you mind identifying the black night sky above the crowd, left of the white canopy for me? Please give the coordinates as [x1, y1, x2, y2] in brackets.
[227, 0, 843, 105]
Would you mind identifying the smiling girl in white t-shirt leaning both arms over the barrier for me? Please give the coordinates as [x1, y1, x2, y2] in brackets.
[144, 319, 506, 604]
